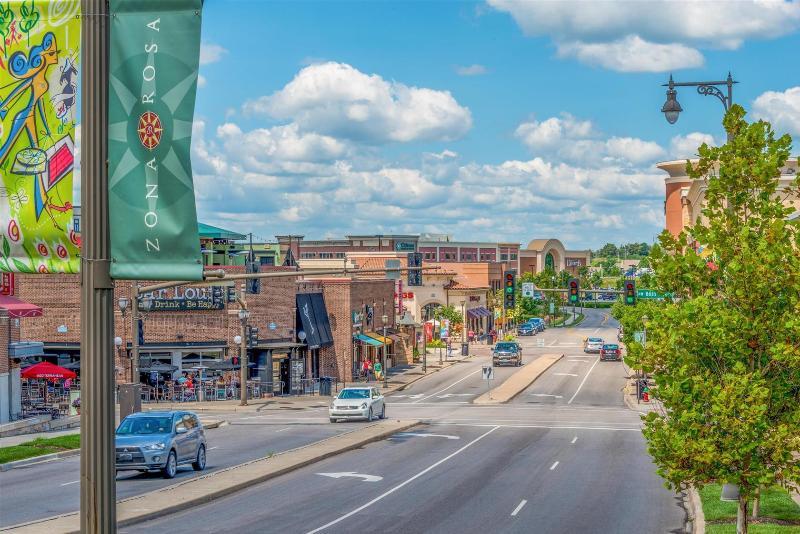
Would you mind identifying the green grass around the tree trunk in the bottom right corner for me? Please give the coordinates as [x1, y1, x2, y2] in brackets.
[699, 484, 800, 534]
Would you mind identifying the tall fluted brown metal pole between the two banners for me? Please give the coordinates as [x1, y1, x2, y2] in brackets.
[80, 0, 117, 534]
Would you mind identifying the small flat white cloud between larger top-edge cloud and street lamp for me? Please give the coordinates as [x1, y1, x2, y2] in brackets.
[558, 35, 703, 72]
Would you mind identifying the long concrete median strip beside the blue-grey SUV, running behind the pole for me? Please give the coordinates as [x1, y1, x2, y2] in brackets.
[0, 420, 419, 533]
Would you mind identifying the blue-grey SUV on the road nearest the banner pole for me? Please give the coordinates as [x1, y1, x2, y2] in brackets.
[114, 410, 206, 478]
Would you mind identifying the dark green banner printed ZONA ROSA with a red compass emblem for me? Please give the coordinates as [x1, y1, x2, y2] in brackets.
[108, 0, 203, 280]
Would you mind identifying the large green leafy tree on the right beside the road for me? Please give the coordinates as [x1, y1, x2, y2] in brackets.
[615, 106, 800, 534]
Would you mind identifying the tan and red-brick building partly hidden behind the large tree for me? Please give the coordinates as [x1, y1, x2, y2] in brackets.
[656, 159, 800, 236]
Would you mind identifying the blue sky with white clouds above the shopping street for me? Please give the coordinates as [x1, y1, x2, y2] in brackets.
[180, 0, 800, 249]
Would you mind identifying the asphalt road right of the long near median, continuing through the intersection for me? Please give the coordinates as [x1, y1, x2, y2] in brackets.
[123, 310, 686, 534]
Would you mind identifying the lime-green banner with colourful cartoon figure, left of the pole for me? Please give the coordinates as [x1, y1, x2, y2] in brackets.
[0, 0, 81, 273]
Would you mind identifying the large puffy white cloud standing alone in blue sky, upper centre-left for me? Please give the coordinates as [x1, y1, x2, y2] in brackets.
[243, 62, 472, 144]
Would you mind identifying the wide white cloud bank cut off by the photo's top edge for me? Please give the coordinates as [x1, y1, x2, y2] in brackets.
[488, 0, 800, 72]
